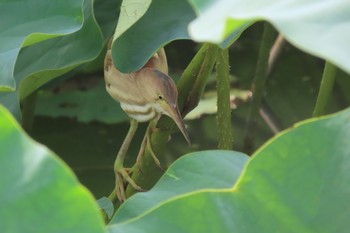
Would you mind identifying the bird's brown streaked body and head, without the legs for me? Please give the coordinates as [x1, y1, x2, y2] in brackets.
[104, 44, 189, 141]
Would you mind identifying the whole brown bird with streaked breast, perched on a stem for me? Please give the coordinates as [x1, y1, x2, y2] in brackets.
[104, 40, 190, 202]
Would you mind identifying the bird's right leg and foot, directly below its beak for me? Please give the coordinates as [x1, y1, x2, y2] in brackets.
[136, 120, 164, 171]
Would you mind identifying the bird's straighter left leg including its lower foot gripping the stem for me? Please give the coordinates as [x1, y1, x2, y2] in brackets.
[114, 119, 142, 201]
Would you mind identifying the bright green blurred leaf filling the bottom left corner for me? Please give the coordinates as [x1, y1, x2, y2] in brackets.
[0, 106, 104, 233]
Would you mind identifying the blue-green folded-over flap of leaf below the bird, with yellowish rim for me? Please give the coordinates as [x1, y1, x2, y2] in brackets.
[111, 150, 248, 223]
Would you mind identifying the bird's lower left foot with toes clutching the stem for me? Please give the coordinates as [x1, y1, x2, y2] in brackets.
[114, 166, 145, 202]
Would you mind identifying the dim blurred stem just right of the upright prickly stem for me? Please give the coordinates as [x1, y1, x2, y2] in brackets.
[244, 22, 276, 153]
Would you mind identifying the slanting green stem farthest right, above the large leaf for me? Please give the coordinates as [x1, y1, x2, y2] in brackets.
[312, 61, 337, 117]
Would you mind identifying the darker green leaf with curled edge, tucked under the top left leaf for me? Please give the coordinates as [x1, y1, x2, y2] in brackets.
[0, 0, 103, 118]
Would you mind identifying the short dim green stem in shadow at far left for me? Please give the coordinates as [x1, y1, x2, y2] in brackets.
[22, 91, 38, 133]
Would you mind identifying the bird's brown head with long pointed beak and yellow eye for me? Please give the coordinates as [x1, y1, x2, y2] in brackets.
[137, 68, 190, 143]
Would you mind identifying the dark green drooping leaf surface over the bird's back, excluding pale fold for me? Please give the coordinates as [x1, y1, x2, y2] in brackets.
[112, 0, 195, 73]
